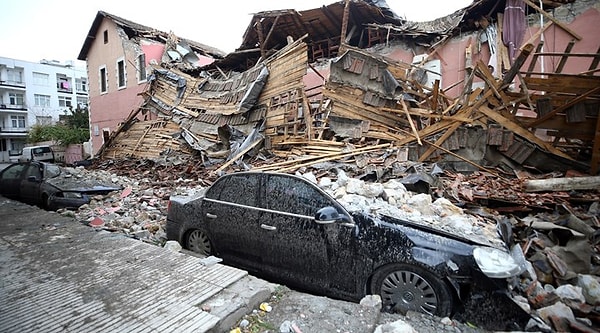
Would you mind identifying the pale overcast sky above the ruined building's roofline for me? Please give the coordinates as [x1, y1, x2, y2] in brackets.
[0, 0, 473, 66]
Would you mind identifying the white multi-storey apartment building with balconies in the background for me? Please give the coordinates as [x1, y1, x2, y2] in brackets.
[0, 57, 89, 163]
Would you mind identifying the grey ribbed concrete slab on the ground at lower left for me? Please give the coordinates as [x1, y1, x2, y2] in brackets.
[0, 197, 273, 332]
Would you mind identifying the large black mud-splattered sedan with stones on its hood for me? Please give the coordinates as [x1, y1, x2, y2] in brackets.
[167, 172, 529, 329]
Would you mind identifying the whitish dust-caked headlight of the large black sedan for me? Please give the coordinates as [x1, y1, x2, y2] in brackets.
[473, 246, 525, 278]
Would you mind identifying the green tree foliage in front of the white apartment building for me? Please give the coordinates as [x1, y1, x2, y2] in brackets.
[27, 106, 90, 145]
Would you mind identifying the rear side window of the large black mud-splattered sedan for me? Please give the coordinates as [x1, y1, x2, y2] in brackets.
[206, 174, 260, 206]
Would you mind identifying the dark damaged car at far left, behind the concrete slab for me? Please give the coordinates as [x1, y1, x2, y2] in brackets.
[0, 161, 121, 210]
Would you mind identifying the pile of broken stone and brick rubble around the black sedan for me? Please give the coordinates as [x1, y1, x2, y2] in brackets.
[61, 160, 600, 332]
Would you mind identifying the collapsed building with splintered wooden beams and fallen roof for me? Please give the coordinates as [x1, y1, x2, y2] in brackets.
[99, 1, 600, 175]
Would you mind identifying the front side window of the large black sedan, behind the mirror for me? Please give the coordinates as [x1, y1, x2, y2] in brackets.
[266, 175, 336, 216]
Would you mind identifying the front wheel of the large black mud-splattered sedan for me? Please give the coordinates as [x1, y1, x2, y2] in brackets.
[371, 264, 454, 317]
